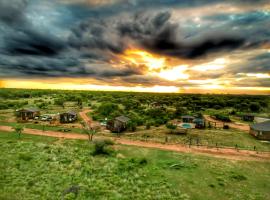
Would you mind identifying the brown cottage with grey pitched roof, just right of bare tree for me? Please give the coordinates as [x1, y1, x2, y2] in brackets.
[106, 116, 130, 133]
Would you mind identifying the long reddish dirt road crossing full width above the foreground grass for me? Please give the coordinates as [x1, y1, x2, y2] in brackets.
[0, 126, 270, 162]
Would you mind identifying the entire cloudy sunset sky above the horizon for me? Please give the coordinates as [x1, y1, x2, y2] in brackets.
[0, 0, 270, 94]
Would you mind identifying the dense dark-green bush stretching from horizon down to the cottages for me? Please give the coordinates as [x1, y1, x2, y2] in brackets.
[0, 89, 270, 127]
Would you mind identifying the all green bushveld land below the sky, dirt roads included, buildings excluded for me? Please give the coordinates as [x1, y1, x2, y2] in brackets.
[0, 89, 270, 200]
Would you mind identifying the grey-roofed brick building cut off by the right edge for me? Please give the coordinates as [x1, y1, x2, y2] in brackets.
[250, 120, 270, 140]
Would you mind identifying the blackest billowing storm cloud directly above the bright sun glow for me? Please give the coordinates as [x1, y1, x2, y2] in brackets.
[118, 12, 245, 59]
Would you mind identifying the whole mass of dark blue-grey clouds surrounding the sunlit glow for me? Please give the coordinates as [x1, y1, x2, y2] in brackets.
[0, 0, 269, 84]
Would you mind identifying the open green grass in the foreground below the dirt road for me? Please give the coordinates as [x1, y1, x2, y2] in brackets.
[0, 132, 270, 200]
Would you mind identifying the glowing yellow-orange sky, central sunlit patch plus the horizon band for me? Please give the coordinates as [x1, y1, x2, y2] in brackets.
[0, 49, 270, 94]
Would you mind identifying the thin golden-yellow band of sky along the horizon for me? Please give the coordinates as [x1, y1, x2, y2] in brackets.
[0, 79, 270, 95]
